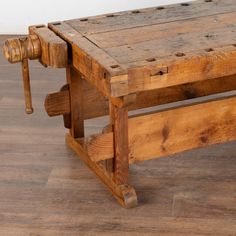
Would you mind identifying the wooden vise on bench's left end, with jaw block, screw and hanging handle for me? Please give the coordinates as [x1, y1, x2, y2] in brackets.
[3, 30, 68, 114]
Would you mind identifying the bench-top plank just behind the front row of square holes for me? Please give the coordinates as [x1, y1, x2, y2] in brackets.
[104, 22, 236, 64]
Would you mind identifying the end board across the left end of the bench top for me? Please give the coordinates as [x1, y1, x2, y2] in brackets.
[48, 22, 127, 97]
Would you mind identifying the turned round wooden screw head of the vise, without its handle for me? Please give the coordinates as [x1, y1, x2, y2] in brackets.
[3, 35, 42, 63]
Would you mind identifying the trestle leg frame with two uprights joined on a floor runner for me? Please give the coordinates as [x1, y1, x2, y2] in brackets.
[66, 67, 137, 208]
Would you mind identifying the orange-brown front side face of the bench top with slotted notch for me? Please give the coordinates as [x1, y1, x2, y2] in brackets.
[111, 45, 236, 97]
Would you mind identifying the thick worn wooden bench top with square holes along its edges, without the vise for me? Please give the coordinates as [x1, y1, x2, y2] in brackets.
[49, 0, 236, 97]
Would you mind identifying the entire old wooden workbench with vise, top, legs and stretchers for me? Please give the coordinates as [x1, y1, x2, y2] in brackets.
[2, 0, 236, 207]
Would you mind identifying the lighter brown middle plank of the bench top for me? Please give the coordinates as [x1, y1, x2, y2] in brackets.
[86, 11, 236, 48]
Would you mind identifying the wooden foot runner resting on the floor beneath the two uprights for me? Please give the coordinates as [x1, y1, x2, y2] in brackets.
[65, 134, 138, 208]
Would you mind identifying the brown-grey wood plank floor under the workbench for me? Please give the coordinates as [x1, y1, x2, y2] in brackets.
[0, 36, 236, 236]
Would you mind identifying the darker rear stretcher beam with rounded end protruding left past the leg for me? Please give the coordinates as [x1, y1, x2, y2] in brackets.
[45, 75, 236, 119]
